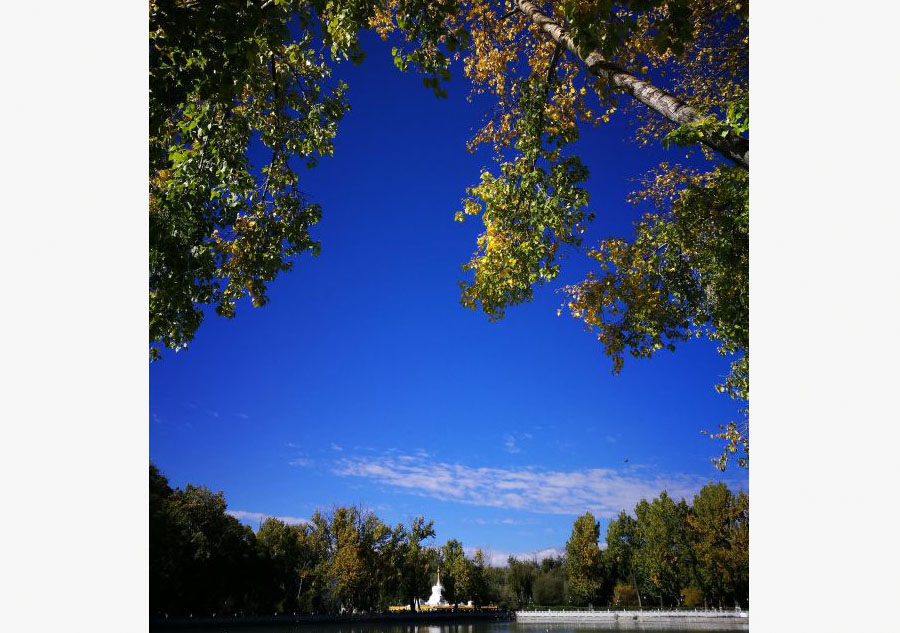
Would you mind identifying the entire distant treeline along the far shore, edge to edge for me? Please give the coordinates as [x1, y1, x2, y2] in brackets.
[150, 464, 747, 615]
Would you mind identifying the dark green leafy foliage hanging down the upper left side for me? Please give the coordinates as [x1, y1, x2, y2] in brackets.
[149, 0, 362, 357]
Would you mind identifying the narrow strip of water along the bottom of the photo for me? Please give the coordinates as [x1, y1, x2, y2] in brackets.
[167, 618, 749, 633]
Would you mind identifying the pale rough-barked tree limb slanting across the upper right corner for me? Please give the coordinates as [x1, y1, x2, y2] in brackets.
[516, 0, 750, 170]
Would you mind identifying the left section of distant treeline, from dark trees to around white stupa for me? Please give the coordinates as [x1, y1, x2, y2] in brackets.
[150, 464, 490, 615]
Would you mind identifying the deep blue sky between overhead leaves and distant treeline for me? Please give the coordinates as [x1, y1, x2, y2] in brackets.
[149, 30, 747, 559]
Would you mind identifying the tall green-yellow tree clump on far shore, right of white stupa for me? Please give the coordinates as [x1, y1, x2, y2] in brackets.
[566, 483, 750, 607]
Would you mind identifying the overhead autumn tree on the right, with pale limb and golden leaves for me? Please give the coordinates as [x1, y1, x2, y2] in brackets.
[372, 0, 749, 469]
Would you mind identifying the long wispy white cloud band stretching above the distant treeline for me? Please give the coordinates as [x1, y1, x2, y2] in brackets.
[332, 454, 740, 518]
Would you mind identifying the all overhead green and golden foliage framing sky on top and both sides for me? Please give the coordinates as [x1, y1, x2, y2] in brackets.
[149, 0, 749, 467]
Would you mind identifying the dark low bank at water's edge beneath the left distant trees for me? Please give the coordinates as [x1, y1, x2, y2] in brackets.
[150, 611, 513, 631]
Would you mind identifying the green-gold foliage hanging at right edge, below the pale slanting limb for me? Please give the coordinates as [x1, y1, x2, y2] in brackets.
[565, 164, 750, 470]
